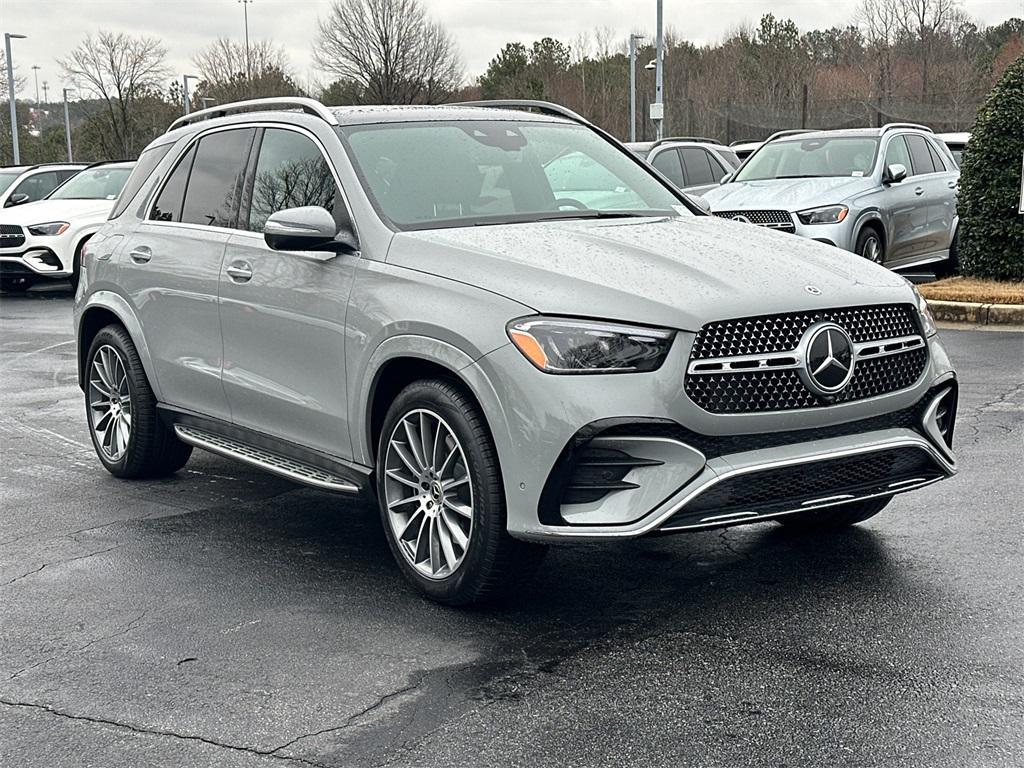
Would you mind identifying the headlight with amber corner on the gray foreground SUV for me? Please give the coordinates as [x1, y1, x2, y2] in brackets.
[506, 316, 675, 374]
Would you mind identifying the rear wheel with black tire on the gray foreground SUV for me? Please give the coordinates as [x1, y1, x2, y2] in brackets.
[85, 325, 191, 478]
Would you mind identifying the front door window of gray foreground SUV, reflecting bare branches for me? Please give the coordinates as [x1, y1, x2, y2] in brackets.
[246, 128, 339, 232]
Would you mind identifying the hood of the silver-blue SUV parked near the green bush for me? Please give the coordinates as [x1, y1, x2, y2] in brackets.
[703, 176, 874, 211]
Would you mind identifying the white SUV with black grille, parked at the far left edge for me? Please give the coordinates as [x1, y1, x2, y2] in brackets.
[0, 163, 135, 292]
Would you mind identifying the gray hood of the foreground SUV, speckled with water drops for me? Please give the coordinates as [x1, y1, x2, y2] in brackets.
[388, 216, 913, 331]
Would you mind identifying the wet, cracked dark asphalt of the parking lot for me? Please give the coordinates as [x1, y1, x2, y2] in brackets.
[0, 290, 1024, 768]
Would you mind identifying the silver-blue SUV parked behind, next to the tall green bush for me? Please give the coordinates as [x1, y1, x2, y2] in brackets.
[703, 123, 959, 272]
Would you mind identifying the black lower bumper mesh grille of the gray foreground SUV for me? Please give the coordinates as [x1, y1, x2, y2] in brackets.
[663, 447, 944, 528]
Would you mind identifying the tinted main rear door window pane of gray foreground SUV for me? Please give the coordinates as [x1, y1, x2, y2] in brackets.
[181, 128, 256, 227]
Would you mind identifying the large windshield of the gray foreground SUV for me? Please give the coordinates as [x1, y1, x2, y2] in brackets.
[341, 120, 689, 229]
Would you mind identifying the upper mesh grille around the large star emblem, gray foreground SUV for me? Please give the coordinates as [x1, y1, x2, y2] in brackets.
[684, 304, 928, 414]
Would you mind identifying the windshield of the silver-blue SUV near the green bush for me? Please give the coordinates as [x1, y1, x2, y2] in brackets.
[735, 136, 879, 181]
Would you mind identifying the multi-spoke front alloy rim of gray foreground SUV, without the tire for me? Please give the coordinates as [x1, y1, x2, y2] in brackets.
[383, 409, 473, 580]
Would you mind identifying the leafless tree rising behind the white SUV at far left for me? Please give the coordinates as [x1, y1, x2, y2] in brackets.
[57, 30, 167, 158]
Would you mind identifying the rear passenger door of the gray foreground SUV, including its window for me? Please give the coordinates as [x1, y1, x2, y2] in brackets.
[121, 128, 255, 420]
